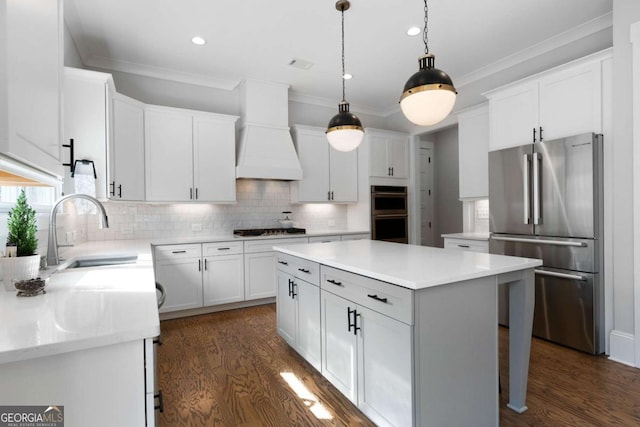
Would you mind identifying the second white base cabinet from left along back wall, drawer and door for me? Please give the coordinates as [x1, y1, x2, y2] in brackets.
[202, 242, 244, 306]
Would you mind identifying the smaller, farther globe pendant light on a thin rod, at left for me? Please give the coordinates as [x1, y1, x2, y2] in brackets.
[326, 0, 364, 151]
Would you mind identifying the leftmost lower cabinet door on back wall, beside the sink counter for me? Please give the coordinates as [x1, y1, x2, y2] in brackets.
[155, 258, 202, 313]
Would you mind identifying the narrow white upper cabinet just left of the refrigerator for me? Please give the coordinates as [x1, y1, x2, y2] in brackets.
[458, 103, 489, 199]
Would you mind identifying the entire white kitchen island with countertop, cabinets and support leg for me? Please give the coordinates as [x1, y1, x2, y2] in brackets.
[274, 240, 541, 426]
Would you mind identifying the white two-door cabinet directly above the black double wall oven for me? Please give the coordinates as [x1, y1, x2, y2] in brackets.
[365, 128, 409, 179]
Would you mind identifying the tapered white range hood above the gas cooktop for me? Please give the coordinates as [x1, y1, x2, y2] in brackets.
[236, 80, 302, 180]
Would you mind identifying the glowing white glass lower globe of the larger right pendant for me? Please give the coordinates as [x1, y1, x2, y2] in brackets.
[400, 89, 456, 126]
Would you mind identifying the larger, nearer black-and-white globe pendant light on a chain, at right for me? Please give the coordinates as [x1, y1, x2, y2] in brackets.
[400, 0, 457, 126]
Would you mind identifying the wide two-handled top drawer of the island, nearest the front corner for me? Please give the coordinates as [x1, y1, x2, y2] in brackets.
[320, 265, 413, 325]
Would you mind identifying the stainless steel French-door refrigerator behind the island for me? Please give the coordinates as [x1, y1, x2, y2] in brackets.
[489, 133, 604, 354]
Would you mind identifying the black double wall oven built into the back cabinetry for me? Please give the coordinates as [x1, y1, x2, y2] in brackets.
[371, 185, 409, 243]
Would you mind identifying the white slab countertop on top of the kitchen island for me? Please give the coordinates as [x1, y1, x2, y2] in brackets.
[274, 240, 542, 290]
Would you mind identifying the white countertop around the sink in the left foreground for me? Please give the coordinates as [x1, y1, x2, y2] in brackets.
[0, 241, 160, 363]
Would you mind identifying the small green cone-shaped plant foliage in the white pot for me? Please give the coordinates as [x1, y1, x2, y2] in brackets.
[7, 189, 38, 256]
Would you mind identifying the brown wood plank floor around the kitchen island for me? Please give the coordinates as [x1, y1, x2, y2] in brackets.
[158, 304, 640, 427]
